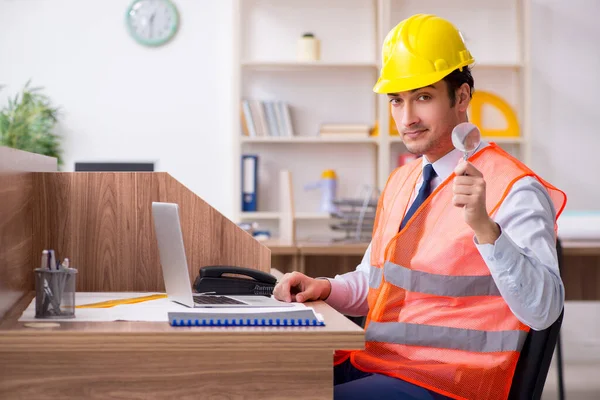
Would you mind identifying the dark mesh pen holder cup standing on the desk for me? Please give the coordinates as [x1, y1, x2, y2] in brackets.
[34, 268, 77, 318]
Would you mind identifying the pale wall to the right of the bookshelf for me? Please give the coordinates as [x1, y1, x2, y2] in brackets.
[531, 0, 600, 210]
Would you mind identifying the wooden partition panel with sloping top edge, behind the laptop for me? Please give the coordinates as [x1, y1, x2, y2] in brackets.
[33, 172, 271, 291]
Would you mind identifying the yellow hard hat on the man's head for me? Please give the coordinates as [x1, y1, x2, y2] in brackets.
[373, 14, 475, 94]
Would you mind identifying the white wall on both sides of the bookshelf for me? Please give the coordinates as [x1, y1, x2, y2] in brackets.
[0, 0, 600, 215]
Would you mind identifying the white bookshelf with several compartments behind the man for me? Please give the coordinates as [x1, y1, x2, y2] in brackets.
[232, 0, 530, 240]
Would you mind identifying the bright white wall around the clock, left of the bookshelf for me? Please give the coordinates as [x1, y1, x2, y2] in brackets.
[0, 0, 233, 216]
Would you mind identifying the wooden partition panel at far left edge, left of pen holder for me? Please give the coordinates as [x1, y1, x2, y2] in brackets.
[0, 147, 57, 318]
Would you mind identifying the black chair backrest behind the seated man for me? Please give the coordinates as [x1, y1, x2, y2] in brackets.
[508, 240, 564, 400]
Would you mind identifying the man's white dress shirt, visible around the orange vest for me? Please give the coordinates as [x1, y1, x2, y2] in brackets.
[325, 143, 565, 330]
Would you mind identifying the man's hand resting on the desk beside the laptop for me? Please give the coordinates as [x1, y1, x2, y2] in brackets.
[273, 272, 331, 303]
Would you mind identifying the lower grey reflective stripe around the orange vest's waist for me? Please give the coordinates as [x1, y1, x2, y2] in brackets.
[366, 321, 528, 353]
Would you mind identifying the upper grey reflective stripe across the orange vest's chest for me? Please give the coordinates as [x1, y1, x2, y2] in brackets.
[380, 261, 500, 297]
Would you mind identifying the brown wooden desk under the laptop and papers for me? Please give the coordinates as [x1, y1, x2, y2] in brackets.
[0, 293, 364, 399]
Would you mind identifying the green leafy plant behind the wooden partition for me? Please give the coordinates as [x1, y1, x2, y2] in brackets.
[0, 82, 62, 165]
